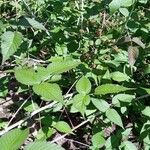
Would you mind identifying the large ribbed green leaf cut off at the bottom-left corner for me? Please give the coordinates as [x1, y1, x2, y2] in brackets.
[0, 129, 29, 150]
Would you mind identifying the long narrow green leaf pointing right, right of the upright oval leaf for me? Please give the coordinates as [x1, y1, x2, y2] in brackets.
[95, 84, 132, 95]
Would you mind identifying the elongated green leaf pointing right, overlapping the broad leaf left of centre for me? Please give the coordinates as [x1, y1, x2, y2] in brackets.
[47, 61, 80, 74]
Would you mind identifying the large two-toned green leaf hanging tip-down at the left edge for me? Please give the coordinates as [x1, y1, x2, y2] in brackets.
[1, 31, 22, 63]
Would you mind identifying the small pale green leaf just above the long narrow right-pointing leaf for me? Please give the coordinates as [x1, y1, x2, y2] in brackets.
[111, 71, 130, 82]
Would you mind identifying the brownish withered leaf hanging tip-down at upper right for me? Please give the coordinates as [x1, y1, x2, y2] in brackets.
[128, 46, 139, 66]
